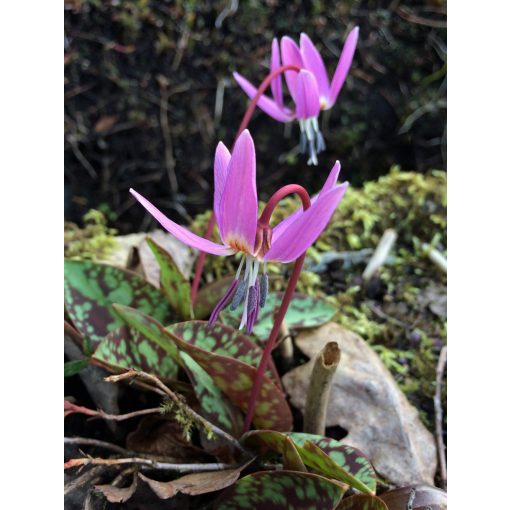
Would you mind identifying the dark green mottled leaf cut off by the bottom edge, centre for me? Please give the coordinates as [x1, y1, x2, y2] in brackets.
[215, 470, 344, 510]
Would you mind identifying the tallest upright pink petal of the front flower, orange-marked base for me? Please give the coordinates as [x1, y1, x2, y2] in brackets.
[218, 129, 258, 253]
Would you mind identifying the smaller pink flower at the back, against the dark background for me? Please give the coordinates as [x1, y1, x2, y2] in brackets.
[234, 27, 359, 165]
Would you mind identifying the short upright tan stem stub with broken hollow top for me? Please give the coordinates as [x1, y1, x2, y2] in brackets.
[303, 342, 340, 435]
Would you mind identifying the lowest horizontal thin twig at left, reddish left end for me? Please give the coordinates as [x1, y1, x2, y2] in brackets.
[64, 457, 237, 473]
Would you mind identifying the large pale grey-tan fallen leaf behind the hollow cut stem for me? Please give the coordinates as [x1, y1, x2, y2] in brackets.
[282, 323, 437, 485]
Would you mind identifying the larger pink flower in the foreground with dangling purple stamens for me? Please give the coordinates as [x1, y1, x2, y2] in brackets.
[130, 130, 348, 332]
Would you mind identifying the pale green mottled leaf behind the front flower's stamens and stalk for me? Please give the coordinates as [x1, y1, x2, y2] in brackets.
[224, 293, 337, 342]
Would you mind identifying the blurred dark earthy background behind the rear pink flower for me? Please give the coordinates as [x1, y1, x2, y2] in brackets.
[65, 0, 446, 232]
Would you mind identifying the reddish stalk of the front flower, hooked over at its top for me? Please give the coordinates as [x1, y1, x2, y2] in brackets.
[243, 184, 311, 433]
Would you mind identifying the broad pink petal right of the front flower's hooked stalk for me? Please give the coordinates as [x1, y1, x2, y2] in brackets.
[264, 182, 348, 262]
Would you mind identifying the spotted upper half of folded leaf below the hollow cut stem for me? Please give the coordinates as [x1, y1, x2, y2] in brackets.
[288, 432, 377, 493]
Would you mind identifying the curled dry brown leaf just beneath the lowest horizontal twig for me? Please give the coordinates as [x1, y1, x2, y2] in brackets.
[138, 461, 251, 499]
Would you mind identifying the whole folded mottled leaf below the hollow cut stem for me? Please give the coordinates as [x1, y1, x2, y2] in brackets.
[242, 430, 376, 494]
